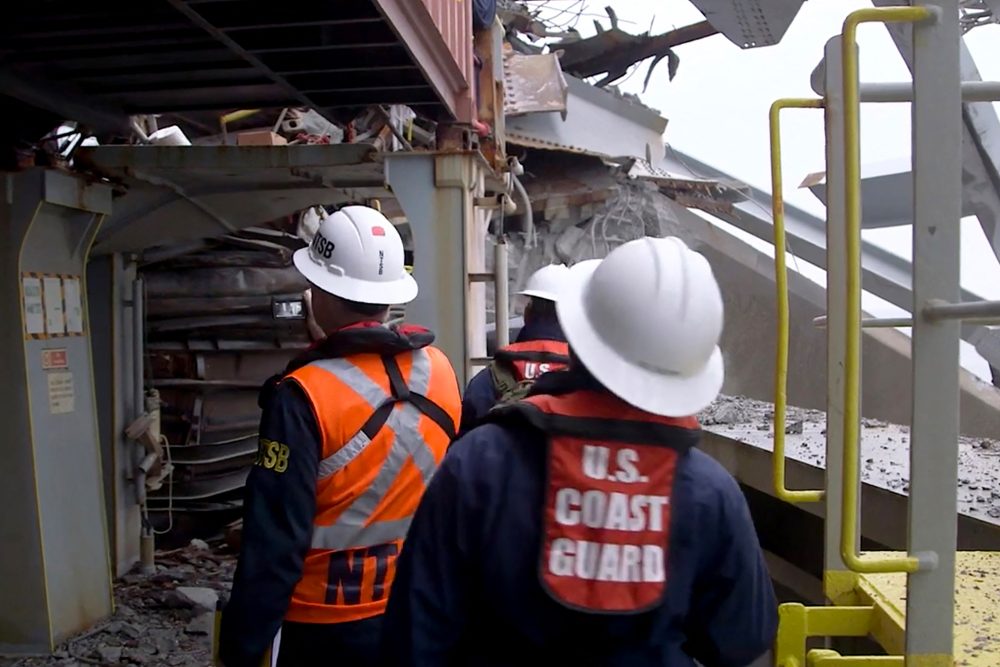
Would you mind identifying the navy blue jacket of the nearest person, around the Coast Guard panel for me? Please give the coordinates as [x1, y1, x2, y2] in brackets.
[383, 370, 777, 667]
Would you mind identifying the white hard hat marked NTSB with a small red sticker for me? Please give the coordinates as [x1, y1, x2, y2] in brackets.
[293, 206, 417, 306]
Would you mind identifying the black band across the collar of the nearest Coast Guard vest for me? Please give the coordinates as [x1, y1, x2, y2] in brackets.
[487, 401, 701, 451]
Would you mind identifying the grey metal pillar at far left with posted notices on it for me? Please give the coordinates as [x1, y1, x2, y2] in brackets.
[0, 169, 113, 653]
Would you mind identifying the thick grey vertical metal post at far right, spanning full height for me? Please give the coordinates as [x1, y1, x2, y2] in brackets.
[906, 0, 962, 667]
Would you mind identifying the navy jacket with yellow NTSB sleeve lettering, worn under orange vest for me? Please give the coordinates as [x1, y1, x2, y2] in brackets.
[219, 323, 442, 667]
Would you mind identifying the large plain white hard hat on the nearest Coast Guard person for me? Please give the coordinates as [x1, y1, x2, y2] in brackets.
[556, 237, 725, 417]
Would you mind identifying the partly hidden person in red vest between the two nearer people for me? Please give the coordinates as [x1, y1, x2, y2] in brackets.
[460, 264, 569, 433]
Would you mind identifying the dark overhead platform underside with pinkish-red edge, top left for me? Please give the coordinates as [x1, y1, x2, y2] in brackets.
[0, 0, 475, 126]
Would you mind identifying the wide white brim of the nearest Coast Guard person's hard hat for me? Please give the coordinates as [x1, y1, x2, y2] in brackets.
[556, 262, 725, 417]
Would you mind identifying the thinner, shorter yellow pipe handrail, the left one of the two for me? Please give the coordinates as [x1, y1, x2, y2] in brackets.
[769, 98, 826, 503]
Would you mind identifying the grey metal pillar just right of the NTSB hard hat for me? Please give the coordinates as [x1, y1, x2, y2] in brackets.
[385, 153, 482, 387]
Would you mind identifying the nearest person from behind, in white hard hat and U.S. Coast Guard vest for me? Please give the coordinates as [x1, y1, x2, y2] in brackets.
[383, 238, 777, 667]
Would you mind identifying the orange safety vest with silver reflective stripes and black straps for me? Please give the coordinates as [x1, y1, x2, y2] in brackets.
[285, 347, 461, 623]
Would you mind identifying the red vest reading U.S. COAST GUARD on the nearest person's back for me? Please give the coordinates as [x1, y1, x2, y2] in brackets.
[491, 390, 700, 614]
